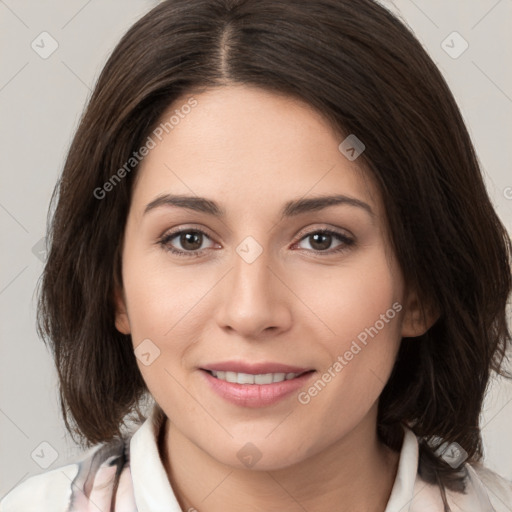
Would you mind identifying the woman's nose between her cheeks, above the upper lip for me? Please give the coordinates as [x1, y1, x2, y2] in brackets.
[216, 251, 293, 339]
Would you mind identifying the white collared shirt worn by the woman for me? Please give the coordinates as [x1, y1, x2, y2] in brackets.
[0, 405, 512, 512]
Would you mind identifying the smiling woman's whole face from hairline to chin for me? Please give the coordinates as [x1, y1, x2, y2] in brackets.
[118, 86, 424, 469]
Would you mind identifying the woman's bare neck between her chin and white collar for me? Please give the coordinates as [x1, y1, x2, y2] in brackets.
[161, 406, 399, 512]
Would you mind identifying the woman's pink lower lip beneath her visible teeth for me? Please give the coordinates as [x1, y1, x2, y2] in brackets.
[201, 370, 315, 407]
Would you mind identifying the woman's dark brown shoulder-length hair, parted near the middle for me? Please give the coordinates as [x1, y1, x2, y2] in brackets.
[38, 0, 511, 506]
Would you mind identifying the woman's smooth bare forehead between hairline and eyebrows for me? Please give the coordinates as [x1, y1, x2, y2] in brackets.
[133, 85, 381, 215]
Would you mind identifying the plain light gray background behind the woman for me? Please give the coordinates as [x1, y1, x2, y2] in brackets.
[0, 0, 512, 497]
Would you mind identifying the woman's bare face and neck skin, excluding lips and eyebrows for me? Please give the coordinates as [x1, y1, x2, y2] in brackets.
[116, 85, 434, 512]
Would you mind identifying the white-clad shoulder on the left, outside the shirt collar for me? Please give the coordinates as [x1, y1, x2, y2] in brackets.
[0, 440, 128, 512]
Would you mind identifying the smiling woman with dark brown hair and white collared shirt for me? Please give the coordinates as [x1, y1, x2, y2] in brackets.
[1, 0, 512, 512]
